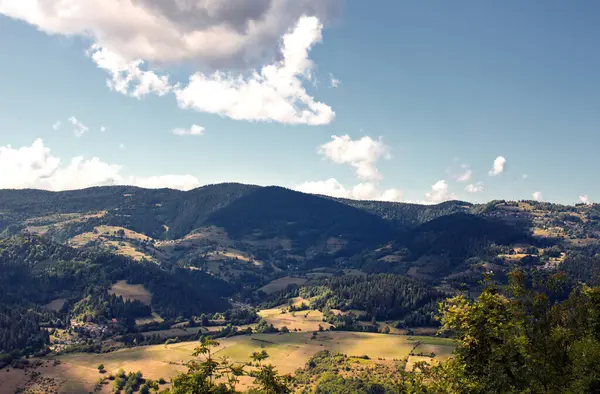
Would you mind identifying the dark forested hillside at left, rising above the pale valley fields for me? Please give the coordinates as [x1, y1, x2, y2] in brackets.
[0, 235, 234, 364]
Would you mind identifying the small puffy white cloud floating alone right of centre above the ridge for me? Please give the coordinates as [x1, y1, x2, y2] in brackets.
[318, 135, 390, 181]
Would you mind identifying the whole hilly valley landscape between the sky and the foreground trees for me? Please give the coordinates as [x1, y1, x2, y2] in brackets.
[0, 184, 600, 394]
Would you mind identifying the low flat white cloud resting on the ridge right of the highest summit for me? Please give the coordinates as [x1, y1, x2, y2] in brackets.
[295, 178, 403, 201]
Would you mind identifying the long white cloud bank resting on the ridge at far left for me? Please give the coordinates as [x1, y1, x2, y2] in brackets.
[0, 139, 200, 191]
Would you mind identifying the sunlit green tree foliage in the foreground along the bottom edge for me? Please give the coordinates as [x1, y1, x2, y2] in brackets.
[168, 271, 600, 394]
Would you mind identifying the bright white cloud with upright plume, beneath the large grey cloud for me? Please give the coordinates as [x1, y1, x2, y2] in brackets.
[175, 17, 335, 125]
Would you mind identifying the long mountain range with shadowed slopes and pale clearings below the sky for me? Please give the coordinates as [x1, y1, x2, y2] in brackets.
[0, 183, 600, 290]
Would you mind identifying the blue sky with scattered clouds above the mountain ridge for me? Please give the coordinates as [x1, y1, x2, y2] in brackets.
[0, 0, 600, 204]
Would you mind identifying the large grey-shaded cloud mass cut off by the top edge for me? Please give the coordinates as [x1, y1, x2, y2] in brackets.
[0, 0, 340, 68]
